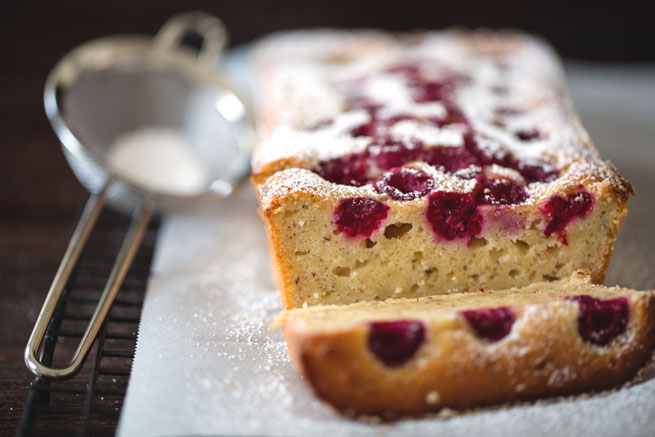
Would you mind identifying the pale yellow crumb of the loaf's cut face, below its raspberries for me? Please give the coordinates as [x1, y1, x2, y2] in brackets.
[269, 190, 625, 308]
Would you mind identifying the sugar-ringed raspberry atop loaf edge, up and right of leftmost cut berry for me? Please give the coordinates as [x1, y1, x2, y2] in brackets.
[375, 168, 434, 200]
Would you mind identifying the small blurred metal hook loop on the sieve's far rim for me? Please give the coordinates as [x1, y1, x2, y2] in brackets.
[154, 11, 228, 67]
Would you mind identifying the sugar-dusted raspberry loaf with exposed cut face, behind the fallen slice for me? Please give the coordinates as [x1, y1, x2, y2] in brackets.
[252, 30, 632, 308]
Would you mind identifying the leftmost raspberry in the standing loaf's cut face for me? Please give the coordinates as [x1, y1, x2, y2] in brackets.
[334, 197, 389, 237]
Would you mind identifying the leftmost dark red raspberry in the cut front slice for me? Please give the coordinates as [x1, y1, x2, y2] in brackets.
[368, 320, 425, 367]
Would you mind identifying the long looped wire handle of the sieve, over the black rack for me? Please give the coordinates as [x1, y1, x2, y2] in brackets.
[25, 180, 154, 379]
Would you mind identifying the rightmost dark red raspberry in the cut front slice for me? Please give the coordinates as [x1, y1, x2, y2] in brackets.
[566, 295, 629, 346]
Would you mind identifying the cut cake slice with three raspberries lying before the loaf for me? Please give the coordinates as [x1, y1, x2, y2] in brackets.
[282, 272, 655, 418]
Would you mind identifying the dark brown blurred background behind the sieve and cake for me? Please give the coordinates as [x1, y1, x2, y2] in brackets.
[0, 0, 655, 434]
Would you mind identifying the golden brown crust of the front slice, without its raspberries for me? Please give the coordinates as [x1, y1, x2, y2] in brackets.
[284, 272, 655, 418]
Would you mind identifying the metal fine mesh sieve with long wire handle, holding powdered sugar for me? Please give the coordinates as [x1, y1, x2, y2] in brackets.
[25, 12, 254, 379]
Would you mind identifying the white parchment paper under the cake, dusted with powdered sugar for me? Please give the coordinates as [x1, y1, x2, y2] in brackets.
[118, 58, 655, 437]
